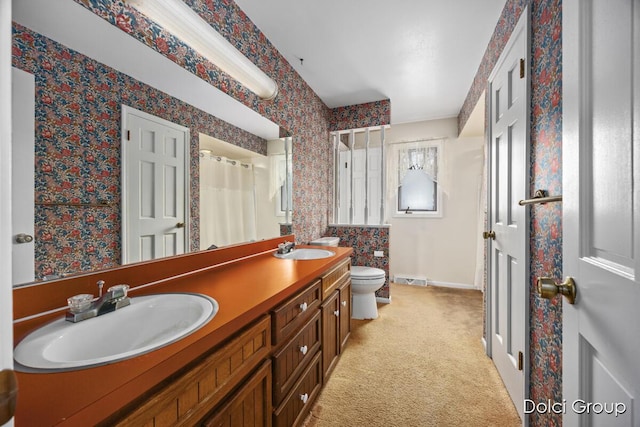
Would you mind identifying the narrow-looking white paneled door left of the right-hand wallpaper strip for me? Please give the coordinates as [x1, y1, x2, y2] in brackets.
[488, 6, 529, 420]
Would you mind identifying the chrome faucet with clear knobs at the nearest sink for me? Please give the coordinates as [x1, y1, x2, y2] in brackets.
[65, 280, 131, 323]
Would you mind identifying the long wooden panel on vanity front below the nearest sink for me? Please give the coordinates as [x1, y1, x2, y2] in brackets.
[110, 316, 271, 427]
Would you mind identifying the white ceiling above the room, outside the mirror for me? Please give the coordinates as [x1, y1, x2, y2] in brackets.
[235, 0, 505, 124]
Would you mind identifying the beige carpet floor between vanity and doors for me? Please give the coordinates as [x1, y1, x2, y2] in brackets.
[304, 284, 521, 427]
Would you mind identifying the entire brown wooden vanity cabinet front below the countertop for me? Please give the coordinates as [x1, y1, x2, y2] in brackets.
[102, 259, 351, 427]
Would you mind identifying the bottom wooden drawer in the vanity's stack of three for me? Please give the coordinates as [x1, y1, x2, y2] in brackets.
[273, 351, 322, 427]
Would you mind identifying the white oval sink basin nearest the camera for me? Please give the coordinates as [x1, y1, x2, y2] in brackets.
[14, 293, 218, 371]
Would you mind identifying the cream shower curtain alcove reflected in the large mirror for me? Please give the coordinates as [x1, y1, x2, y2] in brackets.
[200, 134, 291, 249]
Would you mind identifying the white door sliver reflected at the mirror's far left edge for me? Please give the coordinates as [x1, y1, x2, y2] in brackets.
[11, 68, 36, 285]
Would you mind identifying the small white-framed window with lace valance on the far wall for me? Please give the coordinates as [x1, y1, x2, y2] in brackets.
[392, 141, 442, 217]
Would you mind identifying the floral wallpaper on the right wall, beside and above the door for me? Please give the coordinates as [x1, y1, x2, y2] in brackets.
[458, 0, 562, 426]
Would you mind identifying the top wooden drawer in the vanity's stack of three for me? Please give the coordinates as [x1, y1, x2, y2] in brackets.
[272, 280, 321, 346]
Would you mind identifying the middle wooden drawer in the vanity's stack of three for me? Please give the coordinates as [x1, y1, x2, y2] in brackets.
[273, 310, 322, 406]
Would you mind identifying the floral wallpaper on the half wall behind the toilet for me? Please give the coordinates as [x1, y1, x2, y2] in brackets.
[325, 225, 391, 298]
